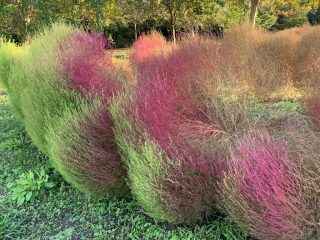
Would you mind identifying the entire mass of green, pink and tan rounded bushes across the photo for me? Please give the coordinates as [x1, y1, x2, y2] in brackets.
[0, 25, 320, 240]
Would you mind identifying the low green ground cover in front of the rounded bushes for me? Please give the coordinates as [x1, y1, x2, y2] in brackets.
[0, 87, 247, 240]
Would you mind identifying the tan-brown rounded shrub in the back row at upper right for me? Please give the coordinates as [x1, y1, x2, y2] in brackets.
[220, 25, 300, 100]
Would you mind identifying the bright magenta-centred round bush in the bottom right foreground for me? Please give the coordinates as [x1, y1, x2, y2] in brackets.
[221, 133, 307, 240]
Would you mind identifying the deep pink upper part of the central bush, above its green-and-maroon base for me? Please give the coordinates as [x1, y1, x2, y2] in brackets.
[133, 38, 219, 148]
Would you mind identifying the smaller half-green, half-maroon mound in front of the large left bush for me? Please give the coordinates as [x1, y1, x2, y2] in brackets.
[47, 101, 127, 197]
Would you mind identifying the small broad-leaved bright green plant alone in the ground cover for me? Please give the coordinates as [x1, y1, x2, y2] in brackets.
[8, 168, 55, 206]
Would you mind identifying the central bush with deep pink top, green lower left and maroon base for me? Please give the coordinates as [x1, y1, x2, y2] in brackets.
[111, 37, 230, 223]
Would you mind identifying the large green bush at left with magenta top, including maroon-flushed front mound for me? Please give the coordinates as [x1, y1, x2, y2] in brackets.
[1, 24, 127, 197]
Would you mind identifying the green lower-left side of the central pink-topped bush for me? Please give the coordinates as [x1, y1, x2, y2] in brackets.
[110, 95, 218, 224]
